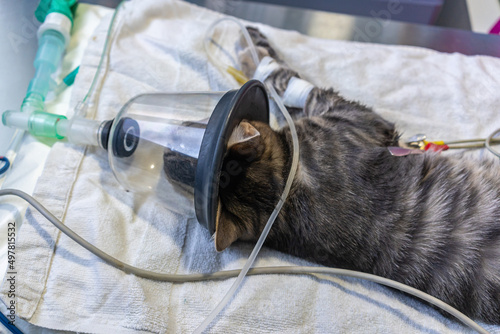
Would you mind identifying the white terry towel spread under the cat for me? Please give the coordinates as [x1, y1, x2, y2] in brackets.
[1, 0, 500, 333]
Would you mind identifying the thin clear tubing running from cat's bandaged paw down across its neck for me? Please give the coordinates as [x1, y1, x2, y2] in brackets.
[194, 20, 299, 333]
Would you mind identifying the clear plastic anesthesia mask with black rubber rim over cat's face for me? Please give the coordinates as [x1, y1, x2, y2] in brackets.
[108, 81, 269, 233]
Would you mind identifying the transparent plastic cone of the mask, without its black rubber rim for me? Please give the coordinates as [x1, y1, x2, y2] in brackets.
[108, 92, 224, 216]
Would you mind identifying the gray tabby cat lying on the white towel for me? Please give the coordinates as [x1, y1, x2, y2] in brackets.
[165, 27, 500, 324]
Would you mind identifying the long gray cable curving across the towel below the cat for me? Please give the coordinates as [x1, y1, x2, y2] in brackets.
[0, 189, 488, 334]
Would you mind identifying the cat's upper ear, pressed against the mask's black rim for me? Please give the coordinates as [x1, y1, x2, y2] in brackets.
[227, 121, 264, 162]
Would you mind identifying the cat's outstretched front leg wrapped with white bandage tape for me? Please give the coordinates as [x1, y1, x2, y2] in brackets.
[240, 27, 398, 146]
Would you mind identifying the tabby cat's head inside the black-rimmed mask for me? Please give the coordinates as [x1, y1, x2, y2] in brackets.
[215, 121, 288, 251]
